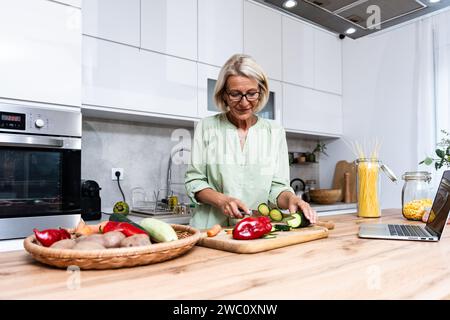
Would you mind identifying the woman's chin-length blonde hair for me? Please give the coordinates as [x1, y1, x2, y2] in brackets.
[214, 54, 269, 113]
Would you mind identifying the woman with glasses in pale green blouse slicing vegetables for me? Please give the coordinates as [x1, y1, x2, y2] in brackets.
[185, 54, 317, 229]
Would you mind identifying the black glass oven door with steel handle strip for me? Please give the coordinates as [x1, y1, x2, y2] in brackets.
[0, 133, 81, 219]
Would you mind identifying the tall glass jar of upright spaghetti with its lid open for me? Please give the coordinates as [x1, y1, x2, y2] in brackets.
[356, 158, 397, 218]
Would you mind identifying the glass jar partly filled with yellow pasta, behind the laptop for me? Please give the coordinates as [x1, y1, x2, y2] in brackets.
[402, 171, 433, 221]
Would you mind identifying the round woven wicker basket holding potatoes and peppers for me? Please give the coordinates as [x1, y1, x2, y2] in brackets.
[24, 224, 201, 269]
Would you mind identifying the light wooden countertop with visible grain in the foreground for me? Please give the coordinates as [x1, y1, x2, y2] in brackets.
[0, 210, 450, 300]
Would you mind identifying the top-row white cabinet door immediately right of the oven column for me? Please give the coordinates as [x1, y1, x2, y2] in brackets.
[83, 0, 140, 47]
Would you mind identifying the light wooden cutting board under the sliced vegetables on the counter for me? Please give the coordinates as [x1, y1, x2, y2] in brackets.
[197, 226, 328, 253]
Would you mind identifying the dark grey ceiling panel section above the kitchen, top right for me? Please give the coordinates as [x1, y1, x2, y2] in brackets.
[255, 0, 450, 39]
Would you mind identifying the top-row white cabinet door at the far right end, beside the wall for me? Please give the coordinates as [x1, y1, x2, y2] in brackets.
[314, 29, 342, 94]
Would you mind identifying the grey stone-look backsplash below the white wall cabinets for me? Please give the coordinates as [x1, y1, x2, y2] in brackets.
[81, 117, 319, 210]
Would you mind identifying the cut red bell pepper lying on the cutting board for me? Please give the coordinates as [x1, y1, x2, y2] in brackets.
[233, 217, 272, 240]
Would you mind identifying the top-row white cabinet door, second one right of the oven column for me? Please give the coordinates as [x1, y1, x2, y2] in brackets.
[141, 0, 197, 60]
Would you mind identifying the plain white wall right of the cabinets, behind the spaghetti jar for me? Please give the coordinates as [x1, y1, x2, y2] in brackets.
[320, 24, 421, 208]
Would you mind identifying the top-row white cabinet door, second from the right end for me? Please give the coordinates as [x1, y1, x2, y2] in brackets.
[283, 17, 315, 88]
